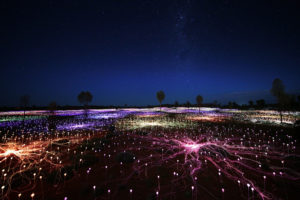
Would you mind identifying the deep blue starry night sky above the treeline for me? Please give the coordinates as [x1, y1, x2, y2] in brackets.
[0, 0, 300, 106]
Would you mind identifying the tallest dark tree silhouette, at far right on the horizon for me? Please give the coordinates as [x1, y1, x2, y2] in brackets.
[270, 78, 287, 123]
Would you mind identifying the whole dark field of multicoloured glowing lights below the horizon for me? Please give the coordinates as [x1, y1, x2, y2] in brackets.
[0, 107, 300, 200]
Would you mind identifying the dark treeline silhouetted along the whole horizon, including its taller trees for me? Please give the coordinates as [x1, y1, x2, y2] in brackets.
[0, 78, 300, 112]
